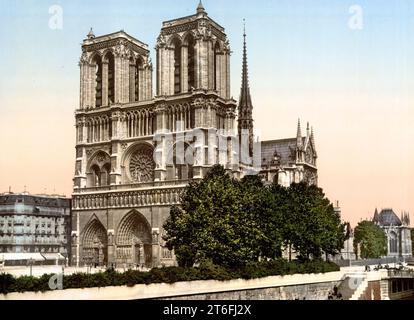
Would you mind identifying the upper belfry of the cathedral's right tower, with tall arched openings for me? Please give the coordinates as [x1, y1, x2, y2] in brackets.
[155, 2, 230, 99]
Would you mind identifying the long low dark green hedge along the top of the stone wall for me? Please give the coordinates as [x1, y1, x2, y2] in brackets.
[0, 259, 339, 294]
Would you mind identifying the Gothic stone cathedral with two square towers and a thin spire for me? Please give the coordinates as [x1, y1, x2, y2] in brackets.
[71, 2, 317, 267]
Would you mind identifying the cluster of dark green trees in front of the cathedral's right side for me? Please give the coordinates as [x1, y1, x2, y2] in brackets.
[164, 166, 345, 267]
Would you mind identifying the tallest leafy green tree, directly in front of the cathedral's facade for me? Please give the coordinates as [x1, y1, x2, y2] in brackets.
[164, 165, 263, 266]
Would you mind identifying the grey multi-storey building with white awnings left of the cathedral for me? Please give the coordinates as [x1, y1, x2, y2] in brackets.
[0, 192, 71, 264]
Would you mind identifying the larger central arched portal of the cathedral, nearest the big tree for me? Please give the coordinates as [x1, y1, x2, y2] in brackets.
[116, 210, 152, 266]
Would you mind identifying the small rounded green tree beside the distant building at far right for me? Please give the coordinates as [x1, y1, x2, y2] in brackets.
[354, 221, 387, 259]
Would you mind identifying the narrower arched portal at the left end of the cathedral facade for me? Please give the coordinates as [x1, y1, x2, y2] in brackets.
[82, 217, 108, 266]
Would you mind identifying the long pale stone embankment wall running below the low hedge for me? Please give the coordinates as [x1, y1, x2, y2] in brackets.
[0, 271, 344, 300]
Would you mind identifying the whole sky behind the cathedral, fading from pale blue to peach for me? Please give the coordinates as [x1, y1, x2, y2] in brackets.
[0, 0, 414, 225]
